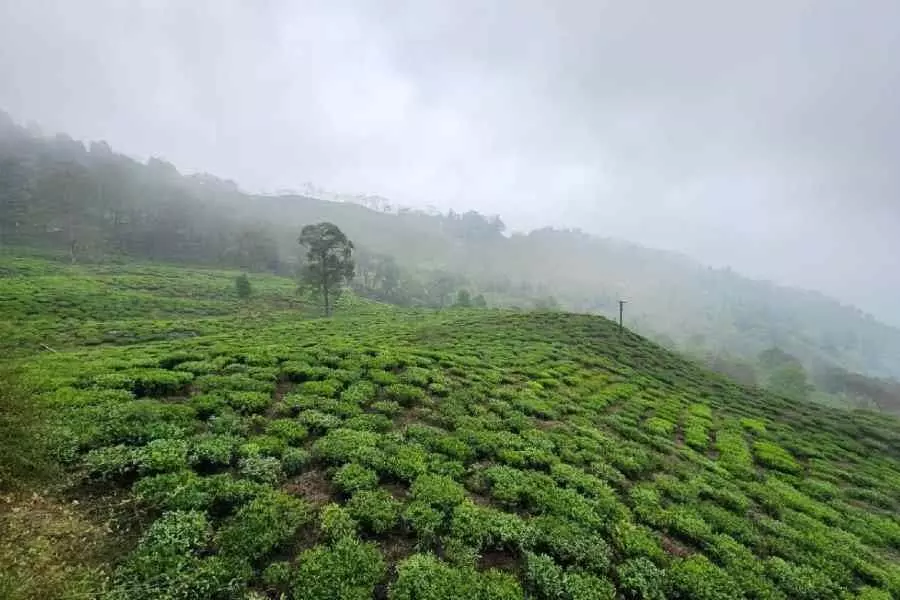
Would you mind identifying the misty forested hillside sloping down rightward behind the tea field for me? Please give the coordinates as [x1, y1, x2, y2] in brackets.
[0, 115, 900, 379]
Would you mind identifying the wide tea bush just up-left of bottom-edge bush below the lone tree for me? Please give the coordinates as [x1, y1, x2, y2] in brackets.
[218, 491, 313, 561]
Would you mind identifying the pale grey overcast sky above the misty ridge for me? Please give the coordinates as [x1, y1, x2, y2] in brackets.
[0, 0, 900, 322]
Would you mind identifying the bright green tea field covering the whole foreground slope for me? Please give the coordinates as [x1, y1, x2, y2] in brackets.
[0, 258, 900, 600]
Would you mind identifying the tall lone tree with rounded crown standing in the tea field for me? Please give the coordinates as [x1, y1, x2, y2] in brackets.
[298, 222, 355, 316]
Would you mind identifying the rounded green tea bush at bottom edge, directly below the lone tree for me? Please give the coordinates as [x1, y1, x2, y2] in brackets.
[293, 537, 385, 600]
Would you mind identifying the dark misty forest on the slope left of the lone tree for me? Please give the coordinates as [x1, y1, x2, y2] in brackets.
[0, 113, 281, 270]
